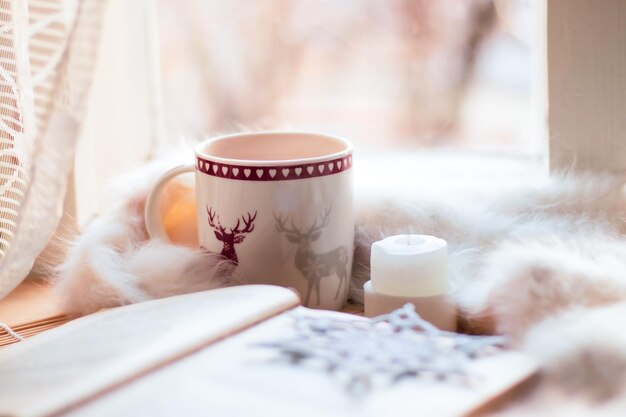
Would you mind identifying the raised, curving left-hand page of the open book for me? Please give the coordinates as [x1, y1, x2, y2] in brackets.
[0, 285, 299, 416]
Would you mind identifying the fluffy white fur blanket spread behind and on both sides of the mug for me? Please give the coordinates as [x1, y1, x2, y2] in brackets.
[56, 152, 626, 416]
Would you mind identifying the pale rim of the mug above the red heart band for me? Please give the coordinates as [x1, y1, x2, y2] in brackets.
[194, 130, 354, 167]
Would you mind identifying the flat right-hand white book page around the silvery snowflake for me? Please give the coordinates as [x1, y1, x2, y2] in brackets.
[70, 307, 536, 417]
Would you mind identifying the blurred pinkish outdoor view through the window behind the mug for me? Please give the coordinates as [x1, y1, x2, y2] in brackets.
[156, 0, 544, 156]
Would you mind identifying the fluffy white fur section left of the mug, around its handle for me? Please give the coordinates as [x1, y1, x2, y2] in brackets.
[55, 154, 235, 314]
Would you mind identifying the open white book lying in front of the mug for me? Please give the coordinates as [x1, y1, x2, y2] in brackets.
[0, 285, 535, 417]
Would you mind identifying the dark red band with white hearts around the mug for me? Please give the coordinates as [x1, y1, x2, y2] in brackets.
[196, 154, 352, 181]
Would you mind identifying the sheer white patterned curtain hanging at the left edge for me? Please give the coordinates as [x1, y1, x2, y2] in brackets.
[0, 0, 106, 298]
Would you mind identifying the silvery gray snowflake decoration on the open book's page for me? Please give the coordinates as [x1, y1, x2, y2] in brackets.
[261, 304, 505, 395]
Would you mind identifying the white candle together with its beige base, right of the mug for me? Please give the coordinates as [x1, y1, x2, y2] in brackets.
[363, 235, 456, 331]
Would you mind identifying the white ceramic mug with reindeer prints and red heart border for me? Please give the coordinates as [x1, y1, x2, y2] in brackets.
[146, 132, 354, 310]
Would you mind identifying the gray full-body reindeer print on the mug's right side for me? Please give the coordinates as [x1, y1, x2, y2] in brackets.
[274, 208, 349, 305]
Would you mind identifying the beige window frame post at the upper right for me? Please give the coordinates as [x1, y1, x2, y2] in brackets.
[546, 0, 626, 172]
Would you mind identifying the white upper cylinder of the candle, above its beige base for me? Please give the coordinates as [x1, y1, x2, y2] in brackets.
[370, 235, 448, 297]
